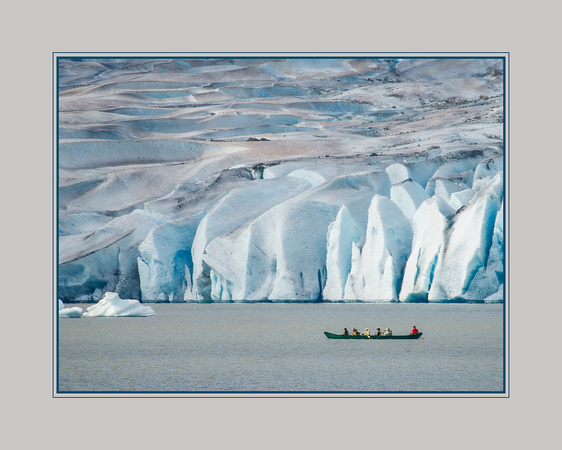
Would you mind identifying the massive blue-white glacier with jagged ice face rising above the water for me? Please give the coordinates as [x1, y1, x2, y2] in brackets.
[56, 57, 505, 302]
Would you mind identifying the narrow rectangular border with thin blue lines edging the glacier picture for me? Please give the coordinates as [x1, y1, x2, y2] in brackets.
[55, 52, 511, 398]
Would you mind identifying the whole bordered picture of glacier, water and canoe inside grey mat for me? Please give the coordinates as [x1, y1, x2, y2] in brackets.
[53, 53, 509, 397]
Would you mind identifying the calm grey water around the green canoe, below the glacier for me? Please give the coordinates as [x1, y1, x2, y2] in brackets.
[58, 303, 504, 393]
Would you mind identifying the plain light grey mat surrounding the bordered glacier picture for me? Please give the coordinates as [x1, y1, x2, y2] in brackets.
[4, 0, 561, 450]
